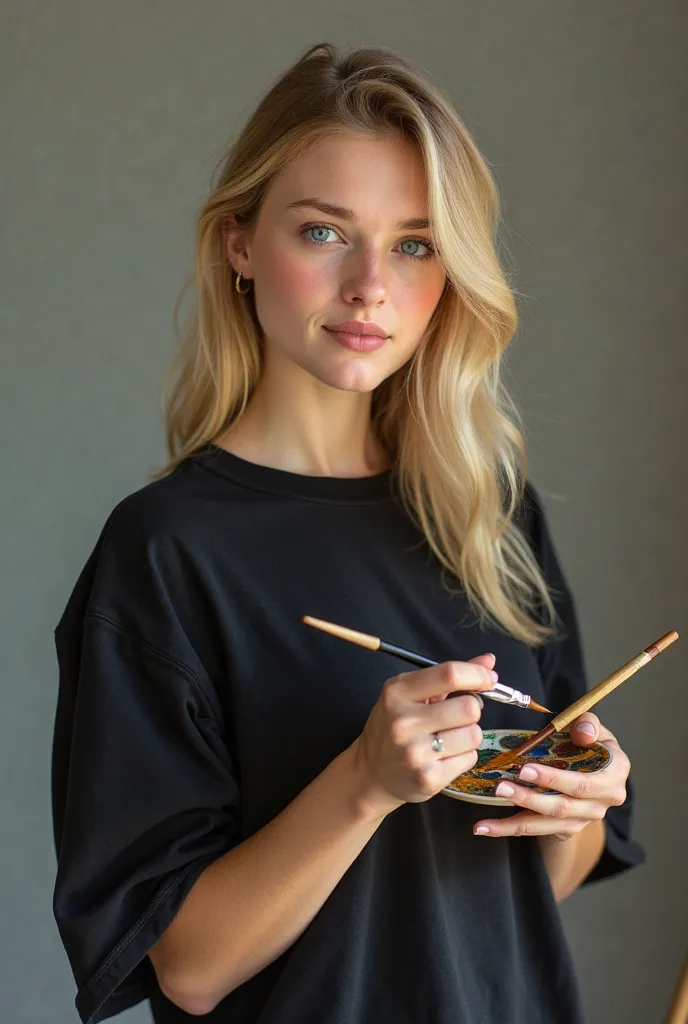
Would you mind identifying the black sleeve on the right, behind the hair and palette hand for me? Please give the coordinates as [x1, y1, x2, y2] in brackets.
[521, 483, 645, 885]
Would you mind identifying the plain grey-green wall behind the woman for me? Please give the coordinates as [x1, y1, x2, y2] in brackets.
[0, 0, 688, 1024]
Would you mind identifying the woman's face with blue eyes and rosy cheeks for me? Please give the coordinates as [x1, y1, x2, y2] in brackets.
[227, 133, 446, 391]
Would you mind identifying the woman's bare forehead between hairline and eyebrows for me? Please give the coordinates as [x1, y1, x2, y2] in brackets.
[265, 132, 427, 220]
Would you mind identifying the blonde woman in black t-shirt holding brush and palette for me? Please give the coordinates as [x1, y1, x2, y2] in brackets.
[53, 44, 642, 1024]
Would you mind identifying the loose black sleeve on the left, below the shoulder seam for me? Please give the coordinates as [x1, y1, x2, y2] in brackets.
[52, 602, 239, 1024]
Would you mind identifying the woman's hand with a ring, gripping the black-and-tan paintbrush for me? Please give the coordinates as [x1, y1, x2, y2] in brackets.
[353, 654, 497, 815]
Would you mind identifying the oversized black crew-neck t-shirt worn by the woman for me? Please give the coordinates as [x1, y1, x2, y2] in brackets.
[53, 444, 642, 1024]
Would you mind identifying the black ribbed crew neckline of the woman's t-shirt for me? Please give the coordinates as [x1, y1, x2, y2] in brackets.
[190, 441, 392, 503]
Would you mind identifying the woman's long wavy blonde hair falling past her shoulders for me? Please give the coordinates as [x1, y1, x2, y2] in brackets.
[153, 43, 556, 647]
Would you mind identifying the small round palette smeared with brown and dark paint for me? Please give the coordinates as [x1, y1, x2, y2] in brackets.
[442, 729, 611, 807]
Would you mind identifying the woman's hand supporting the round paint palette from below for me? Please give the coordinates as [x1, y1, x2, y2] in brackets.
[473, 713, 631, 841]
